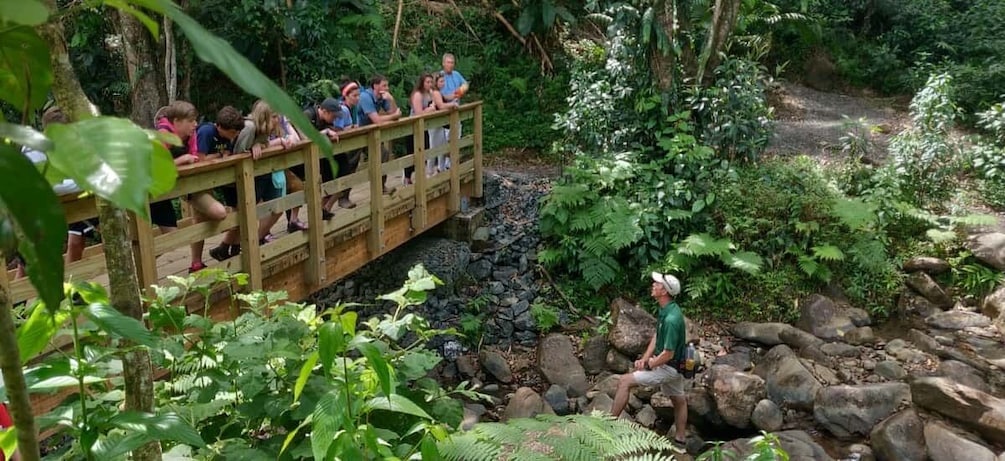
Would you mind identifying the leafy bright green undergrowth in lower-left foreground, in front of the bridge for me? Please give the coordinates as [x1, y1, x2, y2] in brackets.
[14, 266, 480, 460]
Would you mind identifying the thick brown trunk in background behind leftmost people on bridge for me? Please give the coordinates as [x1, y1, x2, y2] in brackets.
[119, 12, 168, 127]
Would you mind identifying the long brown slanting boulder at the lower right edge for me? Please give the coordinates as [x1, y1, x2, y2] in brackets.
[911, 378, 1005, 444]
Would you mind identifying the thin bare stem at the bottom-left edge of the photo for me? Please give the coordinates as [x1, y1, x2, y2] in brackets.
[0, 263, 40, 461]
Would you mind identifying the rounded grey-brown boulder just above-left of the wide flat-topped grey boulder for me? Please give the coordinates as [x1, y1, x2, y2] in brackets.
[754, 344, 821, 411]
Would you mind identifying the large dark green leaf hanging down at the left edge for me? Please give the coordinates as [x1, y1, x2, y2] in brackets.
[0, 144, 66, 308]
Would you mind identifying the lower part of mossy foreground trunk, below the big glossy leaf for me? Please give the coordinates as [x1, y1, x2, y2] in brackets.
[97, 200, 161, 460]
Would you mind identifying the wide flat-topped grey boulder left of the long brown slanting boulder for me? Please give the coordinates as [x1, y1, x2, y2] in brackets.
[813, 383, 911, 439]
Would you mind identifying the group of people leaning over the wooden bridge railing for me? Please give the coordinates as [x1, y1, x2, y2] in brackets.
[9, 53, 468, 277]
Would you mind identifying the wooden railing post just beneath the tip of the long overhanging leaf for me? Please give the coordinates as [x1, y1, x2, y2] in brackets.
[304, 143, 328, 288]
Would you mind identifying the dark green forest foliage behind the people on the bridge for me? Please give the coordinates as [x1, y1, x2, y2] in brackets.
[62, 0, 568, 152]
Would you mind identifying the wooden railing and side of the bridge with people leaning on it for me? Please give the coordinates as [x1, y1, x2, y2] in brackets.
[0, 102, 482, 302]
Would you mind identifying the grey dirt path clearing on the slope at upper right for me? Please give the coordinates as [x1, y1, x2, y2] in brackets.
[768, 83, 908, 163]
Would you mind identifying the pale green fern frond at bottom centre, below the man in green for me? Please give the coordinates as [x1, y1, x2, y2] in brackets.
[439, 413, 673, 461]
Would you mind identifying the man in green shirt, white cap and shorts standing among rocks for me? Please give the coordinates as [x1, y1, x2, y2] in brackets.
[611, 272, 687, 445]
